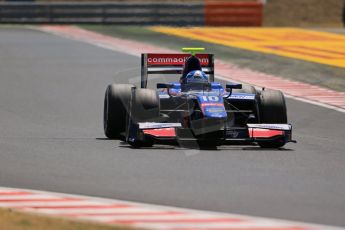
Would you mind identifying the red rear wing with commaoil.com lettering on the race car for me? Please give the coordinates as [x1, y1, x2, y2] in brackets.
[141, 53, 214, 88]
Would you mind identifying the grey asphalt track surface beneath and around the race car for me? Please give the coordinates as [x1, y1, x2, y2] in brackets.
[0, 28, 345, 227]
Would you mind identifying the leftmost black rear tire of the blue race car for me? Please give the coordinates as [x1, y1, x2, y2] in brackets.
[103, 84, 134, 139]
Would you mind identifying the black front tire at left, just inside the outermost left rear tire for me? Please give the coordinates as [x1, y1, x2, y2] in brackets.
[129, 89, 159, 148]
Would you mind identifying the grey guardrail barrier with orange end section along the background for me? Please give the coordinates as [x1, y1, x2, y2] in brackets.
[0, 1, 262, 26]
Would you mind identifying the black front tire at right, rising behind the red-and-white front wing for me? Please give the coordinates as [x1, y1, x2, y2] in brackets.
[258, 90, 287, 148]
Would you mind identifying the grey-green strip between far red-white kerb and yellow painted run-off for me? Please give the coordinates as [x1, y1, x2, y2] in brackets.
[81, 25, 345, 92]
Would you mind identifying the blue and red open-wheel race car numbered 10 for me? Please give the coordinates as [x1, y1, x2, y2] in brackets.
[104, 48, 295, 148]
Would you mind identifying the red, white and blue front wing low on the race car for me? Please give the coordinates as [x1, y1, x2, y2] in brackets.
[127, 122, 296, 145]
